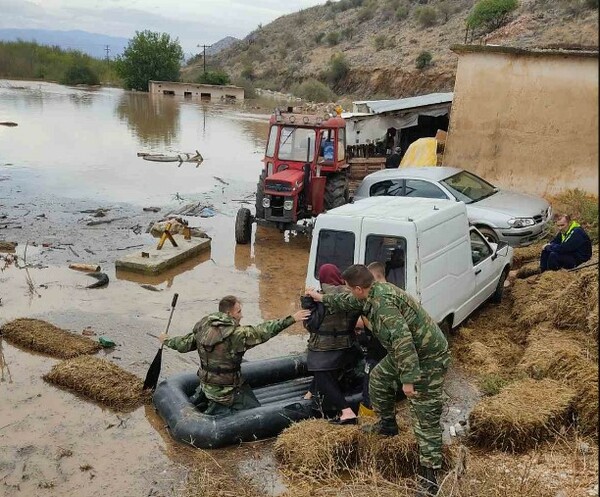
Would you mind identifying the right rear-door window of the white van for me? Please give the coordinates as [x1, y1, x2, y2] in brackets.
[365, 235, 406, 290]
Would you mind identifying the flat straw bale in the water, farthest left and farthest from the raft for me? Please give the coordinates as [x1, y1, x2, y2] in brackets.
[0, 318, 102, 359]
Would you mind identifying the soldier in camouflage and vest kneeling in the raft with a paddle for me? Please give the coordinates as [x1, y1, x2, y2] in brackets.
[159, 295, 310, 415]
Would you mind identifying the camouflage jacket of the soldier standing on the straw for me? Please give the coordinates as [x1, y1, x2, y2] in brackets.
[323, 282, 450, 383]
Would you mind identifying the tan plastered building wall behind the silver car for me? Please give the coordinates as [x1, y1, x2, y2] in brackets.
[443, 52, 598, 195]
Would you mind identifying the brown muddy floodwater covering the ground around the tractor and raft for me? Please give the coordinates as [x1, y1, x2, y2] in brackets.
[0, 80, 476, 497]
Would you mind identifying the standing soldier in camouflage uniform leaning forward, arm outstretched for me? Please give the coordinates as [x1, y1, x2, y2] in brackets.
[307, 264, 450, 495]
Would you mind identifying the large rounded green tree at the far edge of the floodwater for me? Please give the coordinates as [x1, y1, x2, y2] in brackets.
[115, 30, 183, 91]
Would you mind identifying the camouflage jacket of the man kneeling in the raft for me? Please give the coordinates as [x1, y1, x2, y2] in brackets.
[164, 312, 294, 404]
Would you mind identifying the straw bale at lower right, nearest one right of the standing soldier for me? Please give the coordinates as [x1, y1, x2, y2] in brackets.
[469, 379, 575, 452]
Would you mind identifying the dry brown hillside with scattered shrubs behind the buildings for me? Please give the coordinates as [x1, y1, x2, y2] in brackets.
[183, 0, 598, 98]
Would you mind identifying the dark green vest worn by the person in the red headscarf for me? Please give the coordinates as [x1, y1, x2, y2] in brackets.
[308, 284, 360, 352]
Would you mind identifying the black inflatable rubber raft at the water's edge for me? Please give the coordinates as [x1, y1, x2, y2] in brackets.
[153, 354, 362, 449]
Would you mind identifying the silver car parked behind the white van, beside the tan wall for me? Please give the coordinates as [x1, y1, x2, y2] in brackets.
[354, 167, 552, 247]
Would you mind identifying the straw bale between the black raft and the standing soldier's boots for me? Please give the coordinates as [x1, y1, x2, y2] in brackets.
[273, 419, 360, 477]
